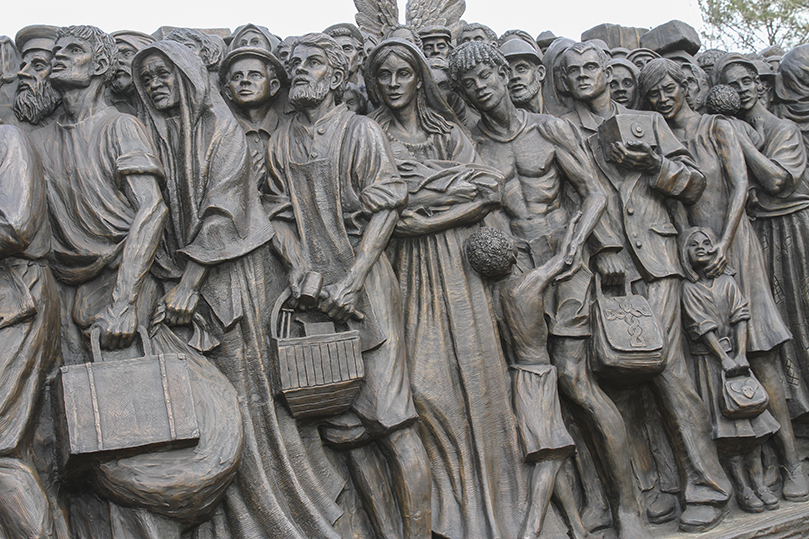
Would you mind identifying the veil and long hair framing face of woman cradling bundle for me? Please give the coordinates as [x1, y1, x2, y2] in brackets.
[365, 38, 458, 135]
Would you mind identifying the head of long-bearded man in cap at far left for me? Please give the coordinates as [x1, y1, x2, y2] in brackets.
[13, 24, 62, 131]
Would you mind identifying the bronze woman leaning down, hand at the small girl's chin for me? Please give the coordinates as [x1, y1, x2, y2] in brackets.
[639, 59, 805, 511]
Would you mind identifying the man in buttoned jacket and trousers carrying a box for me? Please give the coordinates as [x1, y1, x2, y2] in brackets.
[558, 40, 731, 531]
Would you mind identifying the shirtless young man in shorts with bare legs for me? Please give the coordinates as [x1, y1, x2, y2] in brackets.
[450, 41, 647, 539]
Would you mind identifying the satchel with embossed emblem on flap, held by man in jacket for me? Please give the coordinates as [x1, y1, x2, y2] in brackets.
[590, 275, 666, 385]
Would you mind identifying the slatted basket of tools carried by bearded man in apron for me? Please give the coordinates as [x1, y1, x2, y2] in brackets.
[270, 290, 365, 419]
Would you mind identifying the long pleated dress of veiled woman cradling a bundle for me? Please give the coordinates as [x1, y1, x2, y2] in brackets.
[389, 127, 530, 539]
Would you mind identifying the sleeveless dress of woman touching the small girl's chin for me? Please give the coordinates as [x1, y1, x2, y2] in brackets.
[683, 115, 791, 353]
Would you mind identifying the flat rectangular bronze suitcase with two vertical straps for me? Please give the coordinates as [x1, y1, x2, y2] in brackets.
[56, 327, 199, 472]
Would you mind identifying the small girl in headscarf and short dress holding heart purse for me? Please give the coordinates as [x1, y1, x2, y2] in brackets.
[680, 227, 781, 513]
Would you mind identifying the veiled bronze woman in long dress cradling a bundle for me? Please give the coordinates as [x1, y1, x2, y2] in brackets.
[365, 38, 548, 539]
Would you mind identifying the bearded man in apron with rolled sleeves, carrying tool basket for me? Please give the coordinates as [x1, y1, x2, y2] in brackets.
[267, 34, 431, 539]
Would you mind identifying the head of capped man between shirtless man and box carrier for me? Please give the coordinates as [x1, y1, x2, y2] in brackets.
[500, 39, 545, 114]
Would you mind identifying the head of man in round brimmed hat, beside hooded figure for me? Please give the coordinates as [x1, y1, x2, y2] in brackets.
[219, 47, 287, 190]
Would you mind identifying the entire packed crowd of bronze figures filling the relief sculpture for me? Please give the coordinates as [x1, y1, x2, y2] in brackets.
[6, 0, 809, 539]
